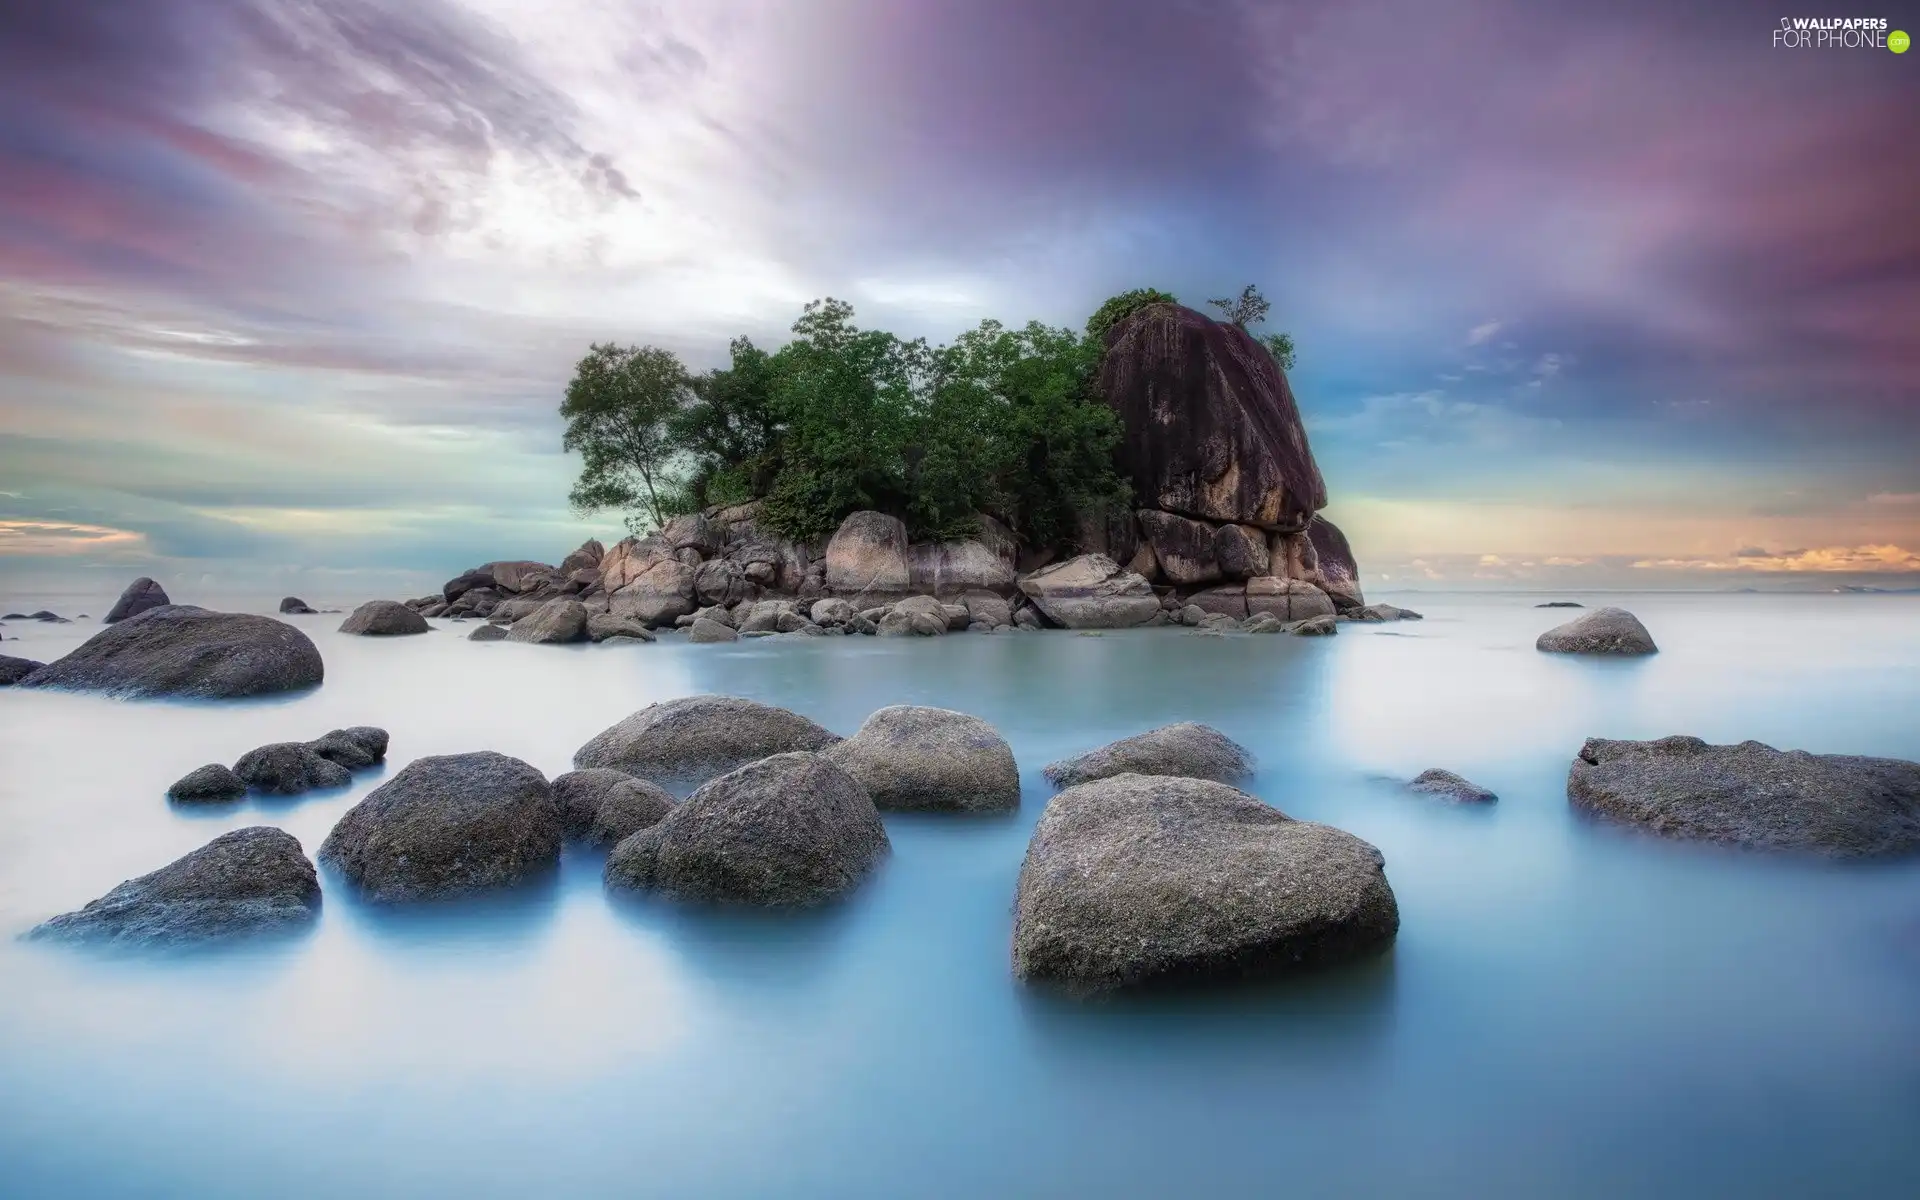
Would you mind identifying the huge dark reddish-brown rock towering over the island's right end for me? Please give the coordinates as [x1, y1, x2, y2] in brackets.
[1098, 303, 1327, 529]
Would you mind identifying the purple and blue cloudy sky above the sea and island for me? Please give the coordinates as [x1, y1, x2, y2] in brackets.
[0, 0, 1920, 599]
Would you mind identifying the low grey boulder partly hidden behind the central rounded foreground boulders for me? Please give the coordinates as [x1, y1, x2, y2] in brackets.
[574, 695, 839, 785]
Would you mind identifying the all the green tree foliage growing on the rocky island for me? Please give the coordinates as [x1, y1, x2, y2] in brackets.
[561, 288, 1290, 545]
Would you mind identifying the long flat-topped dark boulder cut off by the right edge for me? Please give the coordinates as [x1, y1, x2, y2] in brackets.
[1567, 737, 1920, 858]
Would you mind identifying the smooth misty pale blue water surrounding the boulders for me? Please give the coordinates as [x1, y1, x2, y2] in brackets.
[0, 595, 1920, 1198]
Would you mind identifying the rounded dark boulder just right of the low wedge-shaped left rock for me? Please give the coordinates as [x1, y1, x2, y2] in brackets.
[321, 751, 561, 904]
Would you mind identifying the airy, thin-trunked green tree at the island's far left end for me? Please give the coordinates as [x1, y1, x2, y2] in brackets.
[561, 344, 691, 526]
